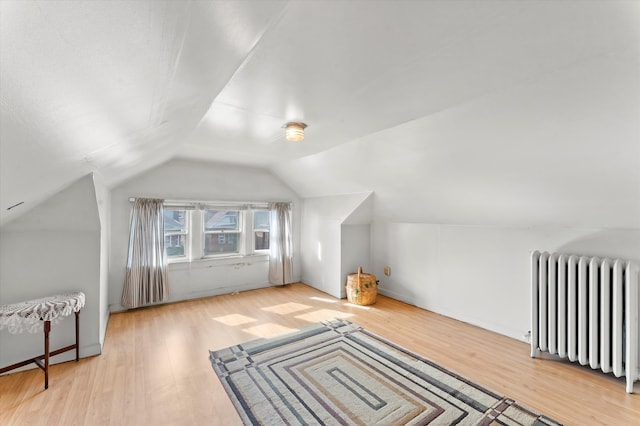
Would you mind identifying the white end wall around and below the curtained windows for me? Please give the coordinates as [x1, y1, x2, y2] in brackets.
[109, 159, 301, 311]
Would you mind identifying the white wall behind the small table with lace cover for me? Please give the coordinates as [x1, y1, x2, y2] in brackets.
[0, 175, 104, 372]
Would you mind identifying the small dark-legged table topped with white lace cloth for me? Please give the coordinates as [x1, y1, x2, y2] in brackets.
[0, 291, 85, 389]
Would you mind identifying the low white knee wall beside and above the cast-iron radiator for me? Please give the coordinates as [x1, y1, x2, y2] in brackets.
[372, 222, 640, 339]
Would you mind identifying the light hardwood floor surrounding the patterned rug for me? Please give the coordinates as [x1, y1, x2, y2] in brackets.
[0, 284, 640, 426]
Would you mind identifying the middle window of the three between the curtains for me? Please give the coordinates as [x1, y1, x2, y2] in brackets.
[203, 210, 242, 256]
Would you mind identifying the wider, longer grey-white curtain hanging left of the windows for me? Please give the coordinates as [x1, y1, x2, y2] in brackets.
[122, 198, 169, 309]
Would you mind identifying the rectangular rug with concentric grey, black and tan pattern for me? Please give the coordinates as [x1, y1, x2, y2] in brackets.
[210, 319, 559, 426]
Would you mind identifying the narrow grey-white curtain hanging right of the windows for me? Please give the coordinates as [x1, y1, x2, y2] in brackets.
[269, 203, 292, 285]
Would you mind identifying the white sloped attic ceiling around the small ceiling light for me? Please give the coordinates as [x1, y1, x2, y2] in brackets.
[0, 0, 640, 227]
